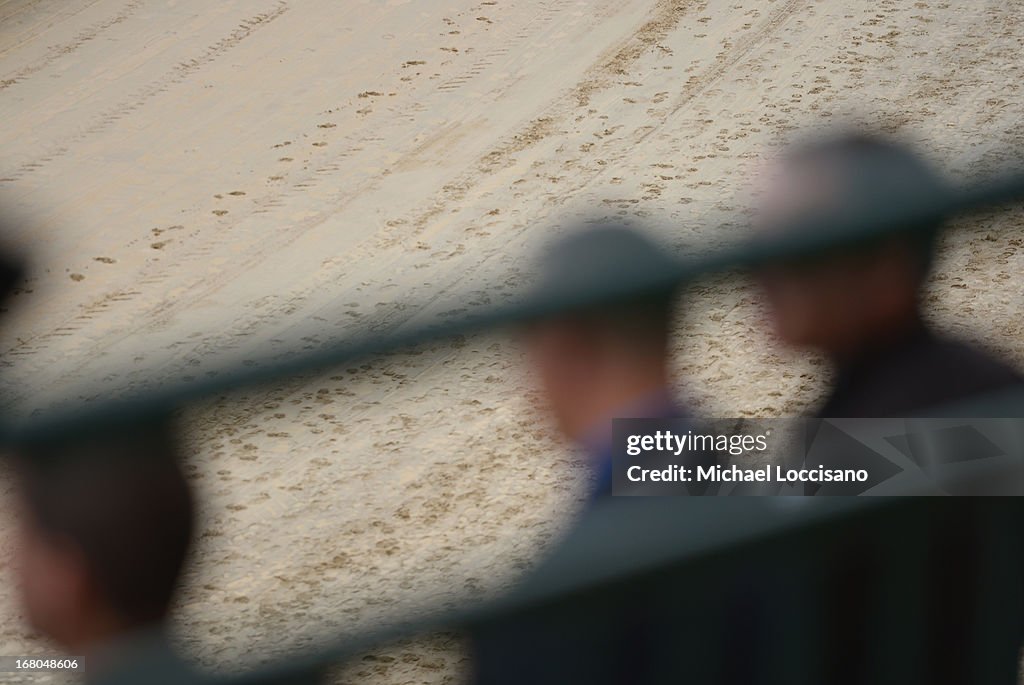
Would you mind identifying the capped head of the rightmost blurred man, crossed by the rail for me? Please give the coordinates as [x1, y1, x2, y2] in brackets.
[757, 135, 939, 357]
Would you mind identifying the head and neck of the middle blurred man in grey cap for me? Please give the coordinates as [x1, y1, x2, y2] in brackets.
[526, 225, 707, 498]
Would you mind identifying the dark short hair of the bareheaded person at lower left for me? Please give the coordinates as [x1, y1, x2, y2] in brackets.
[17, 413, 195, 627]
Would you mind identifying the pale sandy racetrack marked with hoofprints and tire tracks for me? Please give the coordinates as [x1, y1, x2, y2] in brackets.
[0, 0, 1024, 683]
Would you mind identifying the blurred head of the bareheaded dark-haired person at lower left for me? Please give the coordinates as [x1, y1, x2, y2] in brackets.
[16, 423, 194, 651]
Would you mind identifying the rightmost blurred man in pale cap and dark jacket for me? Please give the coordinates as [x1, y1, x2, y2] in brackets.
[758, 134, 1024, 418]
